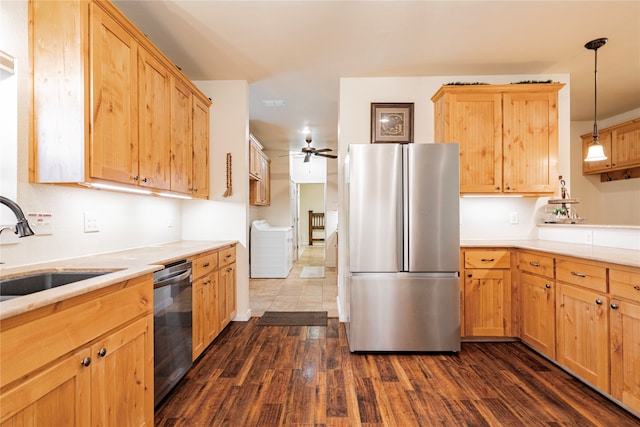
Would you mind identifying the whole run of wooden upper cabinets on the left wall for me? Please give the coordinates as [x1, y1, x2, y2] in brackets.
[29, 0, 211, 198]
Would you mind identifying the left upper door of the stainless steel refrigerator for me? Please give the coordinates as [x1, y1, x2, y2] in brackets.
[349, 144, 403, 272]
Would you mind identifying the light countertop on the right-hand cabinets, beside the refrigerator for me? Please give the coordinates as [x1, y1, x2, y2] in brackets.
[460, 239, 640, 267]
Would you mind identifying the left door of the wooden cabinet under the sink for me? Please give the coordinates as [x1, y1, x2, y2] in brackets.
[0, 348, 91, 427]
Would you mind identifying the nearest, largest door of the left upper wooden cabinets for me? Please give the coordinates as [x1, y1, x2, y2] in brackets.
[89, 3, 138, 184]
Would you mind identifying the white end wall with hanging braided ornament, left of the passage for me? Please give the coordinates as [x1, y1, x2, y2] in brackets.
[182, 80, 251, 320]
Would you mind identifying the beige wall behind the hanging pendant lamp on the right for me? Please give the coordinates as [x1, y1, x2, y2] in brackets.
[570, 108, 640, 226]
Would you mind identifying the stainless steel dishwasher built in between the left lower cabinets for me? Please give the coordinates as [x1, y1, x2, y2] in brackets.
[153, 260, 193, 406]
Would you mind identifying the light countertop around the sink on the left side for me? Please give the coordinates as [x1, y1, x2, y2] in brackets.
[0, 240, 238, 320]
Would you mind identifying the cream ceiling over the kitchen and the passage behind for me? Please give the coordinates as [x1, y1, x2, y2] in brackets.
[114, 0, 640, 154]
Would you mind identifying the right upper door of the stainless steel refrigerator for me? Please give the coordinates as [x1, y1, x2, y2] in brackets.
[405, 144, 460, 272]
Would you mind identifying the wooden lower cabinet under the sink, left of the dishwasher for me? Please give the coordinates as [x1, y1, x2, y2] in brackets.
[0, 275, 154, 427]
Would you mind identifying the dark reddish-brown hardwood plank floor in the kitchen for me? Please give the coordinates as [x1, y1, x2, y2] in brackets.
[155, 318, 640, 427]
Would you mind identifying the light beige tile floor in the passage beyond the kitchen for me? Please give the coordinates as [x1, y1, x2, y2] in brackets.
[249, 246, 338, 317]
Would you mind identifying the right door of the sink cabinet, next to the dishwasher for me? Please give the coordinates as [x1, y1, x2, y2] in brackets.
[91, 315, 154, 426]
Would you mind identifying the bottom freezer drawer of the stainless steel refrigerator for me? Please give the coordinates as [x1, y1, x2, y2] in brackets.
[348, 273, 460, 352]
